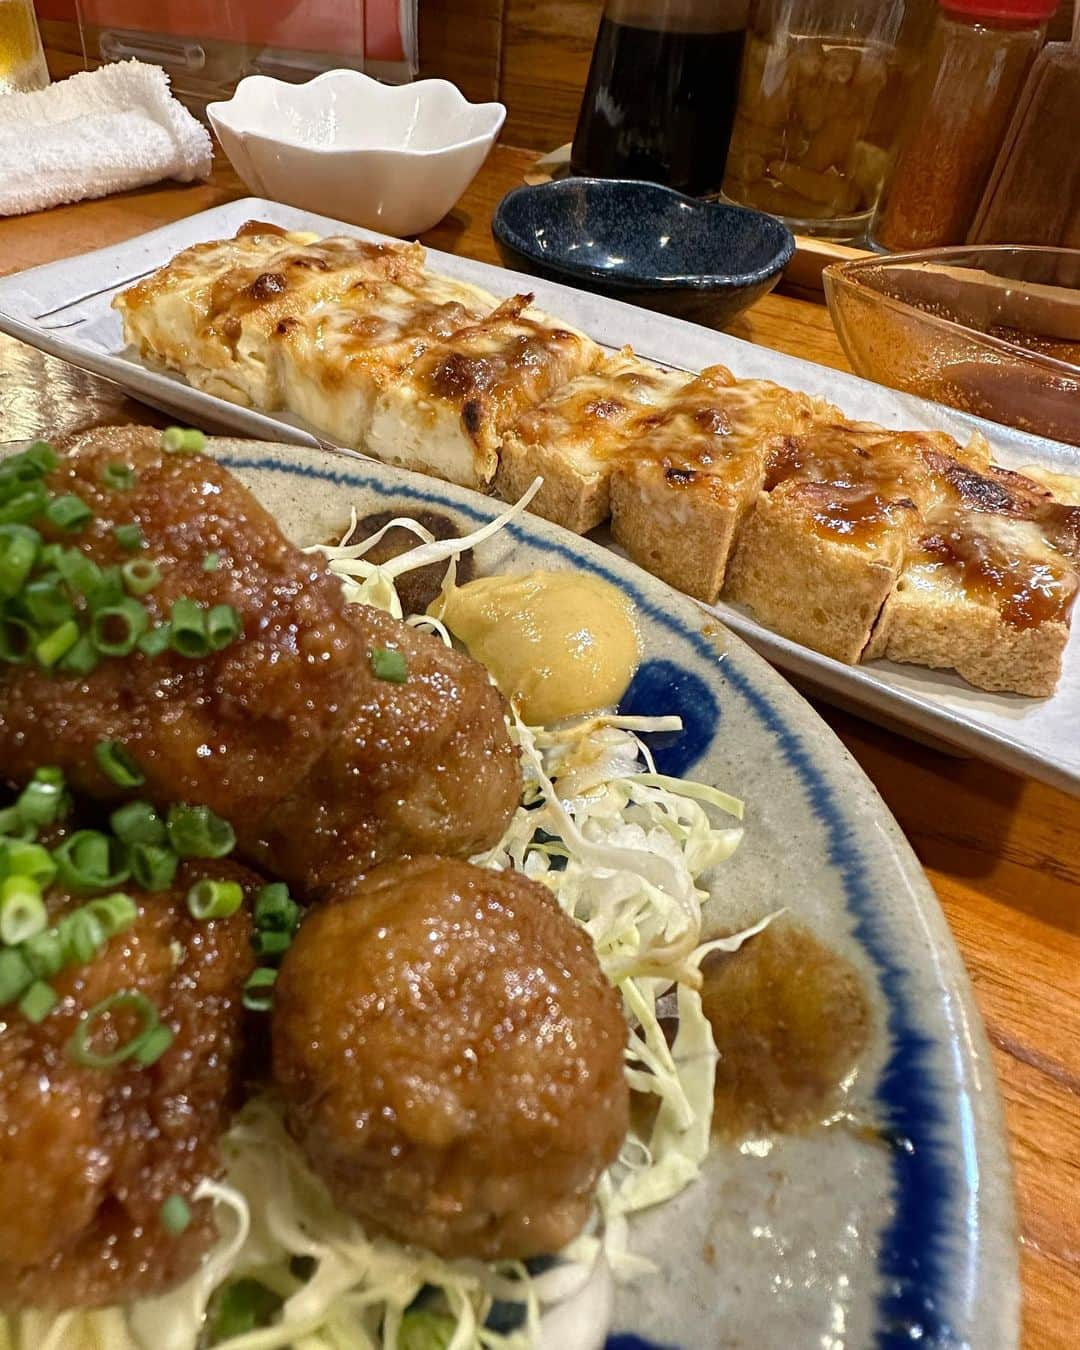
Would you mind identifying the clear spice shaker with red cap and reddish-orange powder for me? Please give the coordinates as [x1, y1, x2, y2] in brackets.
[871, 0, 1057, 250]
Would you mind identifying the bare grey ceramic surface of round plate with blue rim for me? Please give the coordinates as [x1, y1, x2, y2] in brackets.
[213, 441, 1019, 1350]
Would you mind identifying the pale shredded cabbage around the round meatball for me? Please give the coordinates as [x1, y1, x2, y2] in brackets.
[10, 494, 770, 1350]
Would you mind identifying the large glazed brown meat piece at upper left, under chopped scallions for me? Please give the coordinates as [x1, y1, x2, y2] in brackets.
[0, 427, 366, 838]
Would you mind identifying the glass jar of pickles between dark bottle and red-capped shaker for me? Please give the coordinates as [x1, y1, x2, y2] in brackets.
[724, 0, 927, 239]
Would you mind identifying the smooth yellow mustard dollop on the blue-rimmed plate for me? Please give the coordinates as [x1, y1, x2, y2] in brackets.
[431, 571, 640, 726]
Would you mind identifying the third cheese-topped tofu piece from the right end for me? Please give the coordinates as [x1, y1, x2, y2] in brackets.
[610, 366, 838, 603]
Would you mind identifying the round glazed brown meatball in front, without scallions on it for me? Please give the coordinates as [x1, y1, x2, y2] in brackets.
[273, 857, 629, 1260]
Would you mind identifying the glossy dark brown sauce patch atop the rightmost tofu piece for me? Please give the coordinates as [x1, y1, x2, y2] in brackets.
[921, 517, 1077, 629]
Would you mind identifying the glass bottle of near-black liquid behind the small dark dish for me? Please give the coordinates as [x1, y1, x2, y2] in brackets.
[571, 0, 748, 194]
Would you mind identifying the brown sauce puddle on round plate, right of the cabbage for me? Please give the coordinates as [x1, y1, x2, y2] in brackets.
[702, 918, 872, 1138]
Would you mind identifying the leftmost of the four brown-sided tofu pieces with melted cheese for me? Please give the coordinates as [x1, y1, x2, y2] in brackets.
[494, 347, 686, 535]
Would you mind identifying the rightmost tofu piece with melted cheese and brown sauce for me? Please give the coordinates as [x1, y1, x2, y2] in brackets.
[865, 456, 1080, 698]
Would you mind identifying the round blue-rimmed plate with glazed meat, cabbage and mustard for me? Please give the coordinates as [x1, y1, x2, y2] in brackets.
[0, 428, 1018, 1350]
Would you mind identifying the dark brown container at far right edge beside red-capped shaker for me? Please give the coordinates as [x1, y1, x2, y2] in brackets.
[968, 4, 1080, 248]
